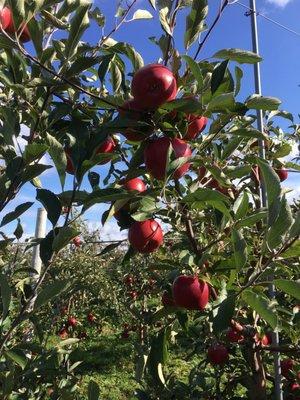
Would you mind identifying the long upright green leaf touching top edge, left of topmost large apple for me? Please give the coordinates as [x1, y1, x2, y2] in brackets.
[65, 1, 90, 59]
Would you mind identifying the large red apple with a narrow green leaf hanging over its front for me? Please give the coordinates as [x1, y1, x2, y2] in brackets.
[144, 137, 192, 180]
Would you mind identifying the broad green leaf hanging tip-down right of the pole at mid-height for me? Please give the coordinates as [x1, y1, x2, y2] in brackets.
[266, 197, 294, 250]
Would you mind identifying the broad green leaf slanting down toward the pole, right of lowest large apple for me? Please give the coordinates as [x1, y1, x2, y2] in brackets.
[242, 290, 279, 330]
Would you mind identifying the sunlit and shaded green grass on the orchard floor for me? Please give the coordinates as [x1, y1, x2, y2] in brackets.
[56, 326, 202, 400]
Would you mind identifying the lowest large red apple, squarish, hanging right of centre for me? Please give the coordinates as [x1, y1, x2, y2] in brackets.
[172, 275, 209, 310]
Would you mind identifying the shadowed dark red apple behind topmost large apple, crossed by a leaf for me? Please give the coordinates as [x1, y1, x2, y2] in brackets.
[119, 99, 153, 142]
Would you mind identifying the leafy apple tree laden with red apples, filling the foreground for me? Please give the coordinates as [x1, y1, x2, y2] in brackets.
[0, 0, 300, 400]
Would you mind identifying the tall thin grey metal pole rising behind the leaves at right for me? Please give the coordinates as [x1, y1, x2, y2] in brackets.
[249, 0, 283, 400]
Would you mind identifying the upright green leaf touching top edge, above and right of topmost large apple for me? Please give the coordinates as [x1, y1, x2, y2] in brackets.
[184, 0, 208, 49]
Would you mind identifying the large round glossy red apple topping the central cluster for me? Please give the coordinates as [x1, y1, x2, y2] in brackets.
[131, 64, 177, 110]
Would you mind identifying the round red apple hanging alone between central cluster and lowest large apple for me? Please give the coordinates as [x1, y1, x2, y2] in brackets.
[128, 219, 164, 254]
